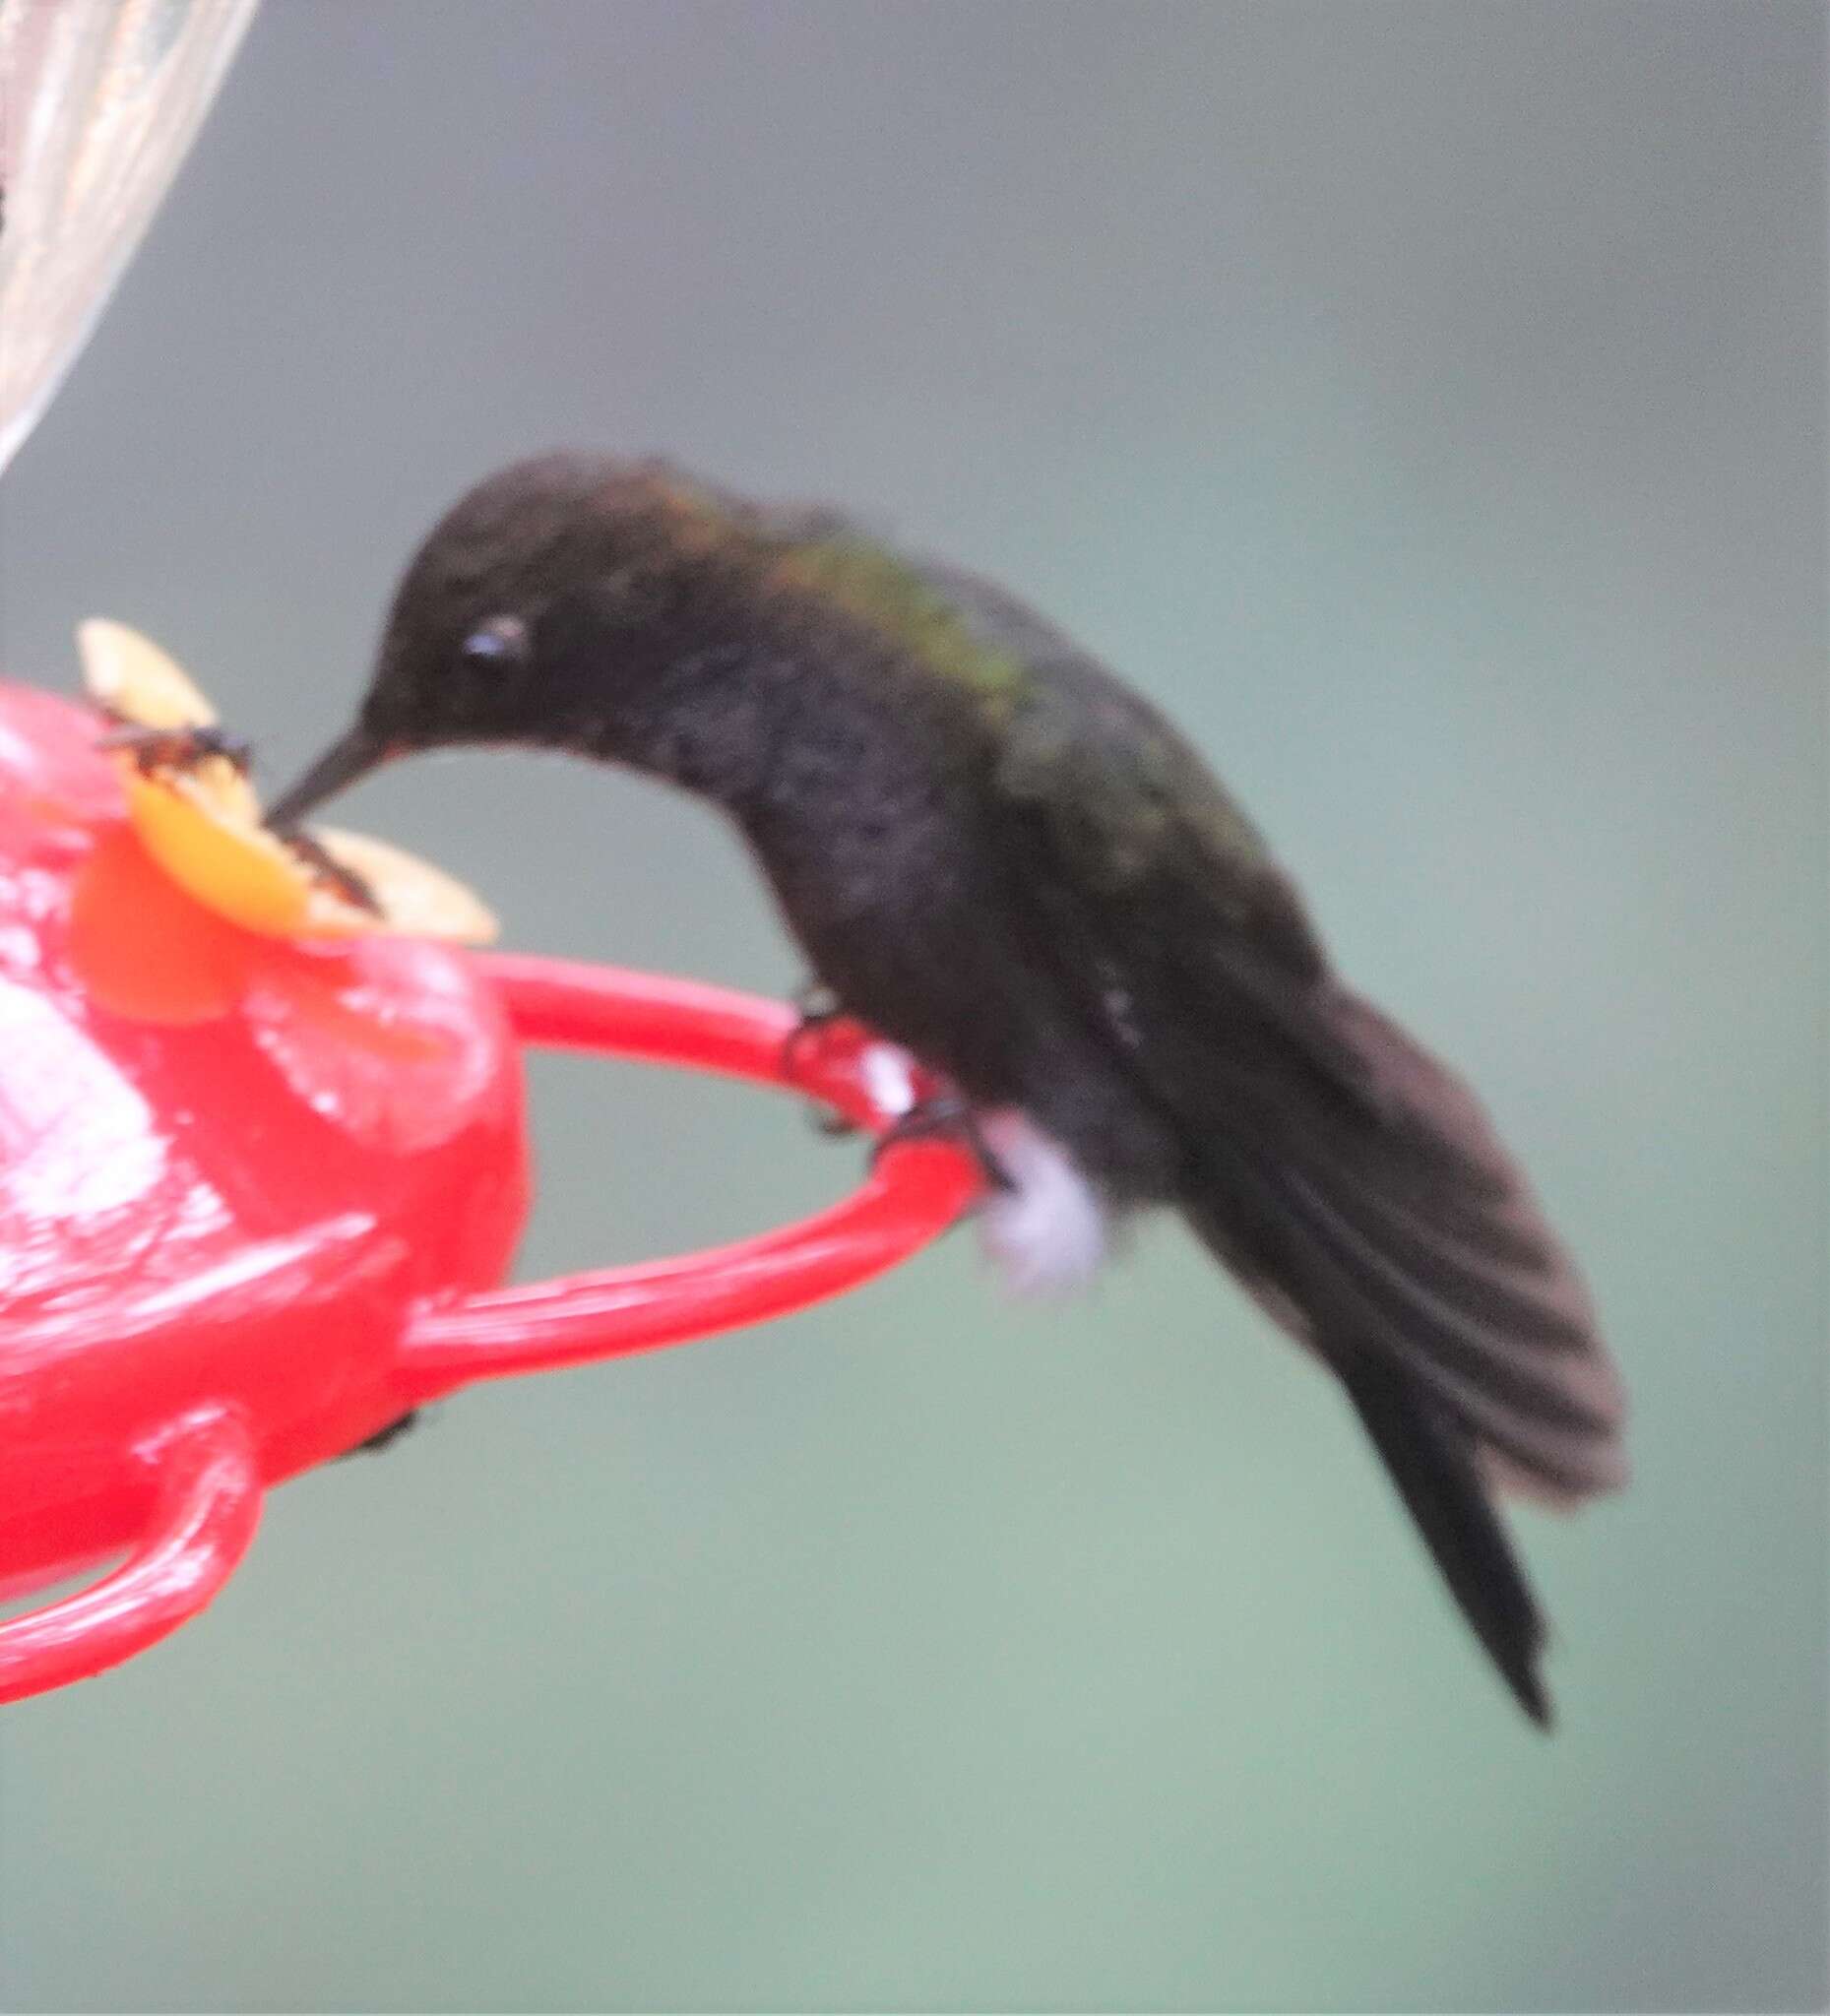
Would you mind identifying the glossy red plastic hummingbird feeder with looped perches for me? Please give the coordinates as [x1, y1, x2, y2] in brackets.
[0, 685, 979, 1699]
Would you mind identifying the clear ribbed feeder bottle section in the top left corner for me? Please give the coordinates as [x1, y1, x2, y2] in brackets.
[0, 0, 256, 470]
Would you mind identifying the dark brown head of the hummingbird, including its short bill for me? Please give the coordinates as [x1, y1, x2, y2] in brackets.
[268, 456, 756, 831]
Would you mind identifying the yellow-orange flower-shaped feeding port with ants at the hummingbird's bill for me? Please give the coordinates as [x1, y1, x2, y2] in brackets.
[77, 617, 496, 946]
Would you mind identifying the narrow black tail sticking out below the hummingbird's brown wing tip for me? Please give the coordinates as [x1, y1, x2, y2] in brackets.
[1340, 1362, 1551, 1730]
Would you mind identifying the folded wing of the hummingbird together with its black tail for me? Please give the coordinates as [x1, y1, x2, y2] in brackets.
[929, 569, 1624, 1720]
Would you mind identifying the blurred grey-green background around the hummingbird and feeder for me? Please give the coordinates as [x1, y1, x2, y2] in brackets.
[0, 0, 1826, 2010]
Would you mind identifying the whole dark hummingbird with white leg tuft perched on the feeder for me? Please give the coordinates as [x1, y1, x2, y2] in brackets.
[268, 454, 1626, 1728]
